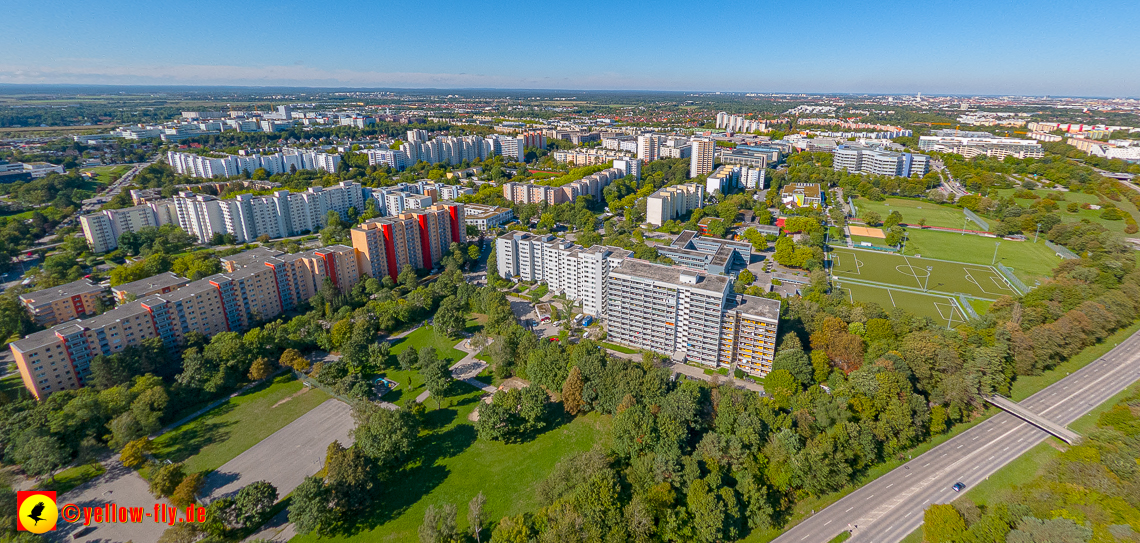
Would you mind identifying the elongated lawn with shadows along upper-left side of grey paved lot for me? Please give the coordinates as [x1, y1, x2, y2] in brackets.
[154, 373, 329, 472]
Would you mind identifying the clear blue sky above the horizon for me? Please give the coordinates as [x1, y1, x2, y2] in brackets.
[0, 0, 1140, 97]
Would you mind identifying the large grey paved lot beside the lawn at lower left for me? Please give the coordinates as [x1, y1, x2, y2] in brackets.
[200, 399, 353, 503]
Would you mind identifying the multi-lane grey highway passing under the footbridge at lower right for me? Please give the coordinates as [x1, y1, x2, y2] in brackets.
[774, 332, 1140, 543]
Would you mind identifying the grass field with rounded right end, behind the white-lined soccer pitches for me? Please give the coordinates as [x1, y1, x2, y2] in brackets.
[903, 228, 1061, 281]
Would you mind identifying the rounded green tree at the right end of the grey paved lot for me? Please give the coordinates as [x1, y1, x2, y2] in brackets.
[352, 403, 420, 468]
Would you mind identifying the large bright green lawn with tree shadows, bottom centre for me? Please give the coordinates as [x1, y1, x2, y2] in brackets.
[293, 389, 611, 543]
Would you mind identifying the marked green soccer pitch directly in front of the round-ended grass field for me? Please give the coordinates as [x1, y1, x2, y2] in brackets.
[831, 248, 1018, 300]
